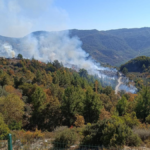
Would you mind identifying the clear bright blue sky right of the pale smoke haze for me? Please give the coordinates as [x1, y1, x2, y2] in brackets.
[54, 0, 150, 30]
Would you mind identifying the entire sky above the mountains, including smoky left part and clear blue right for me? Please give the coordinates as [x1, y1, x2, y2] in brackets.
[0, 0, 150, 37]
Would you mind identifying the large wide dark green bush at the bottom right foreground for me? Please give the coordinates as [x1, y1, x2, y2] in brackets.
[82, 118, 141, 146]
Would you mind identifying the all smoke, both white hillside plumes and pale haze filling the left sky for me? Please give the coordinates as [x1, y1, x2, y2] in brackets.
[0, 0, 135, 92]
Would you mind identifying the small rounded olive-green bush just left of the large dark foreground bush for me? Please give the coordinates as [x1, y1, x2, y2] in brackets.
[53, 129, 77, 148]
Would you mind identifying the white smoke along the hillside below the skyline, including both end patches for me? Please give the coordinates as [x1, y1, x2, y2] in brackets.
[1, 31, 136, 93]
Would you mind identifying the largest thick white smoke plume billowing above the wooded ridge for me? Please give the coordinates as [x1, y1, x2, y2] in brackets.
[10, 31, 108, 74]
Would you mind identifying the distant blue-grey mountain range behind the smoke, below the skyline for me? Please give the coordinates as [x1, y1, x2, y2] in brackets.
[0, 28, 150, 66]
